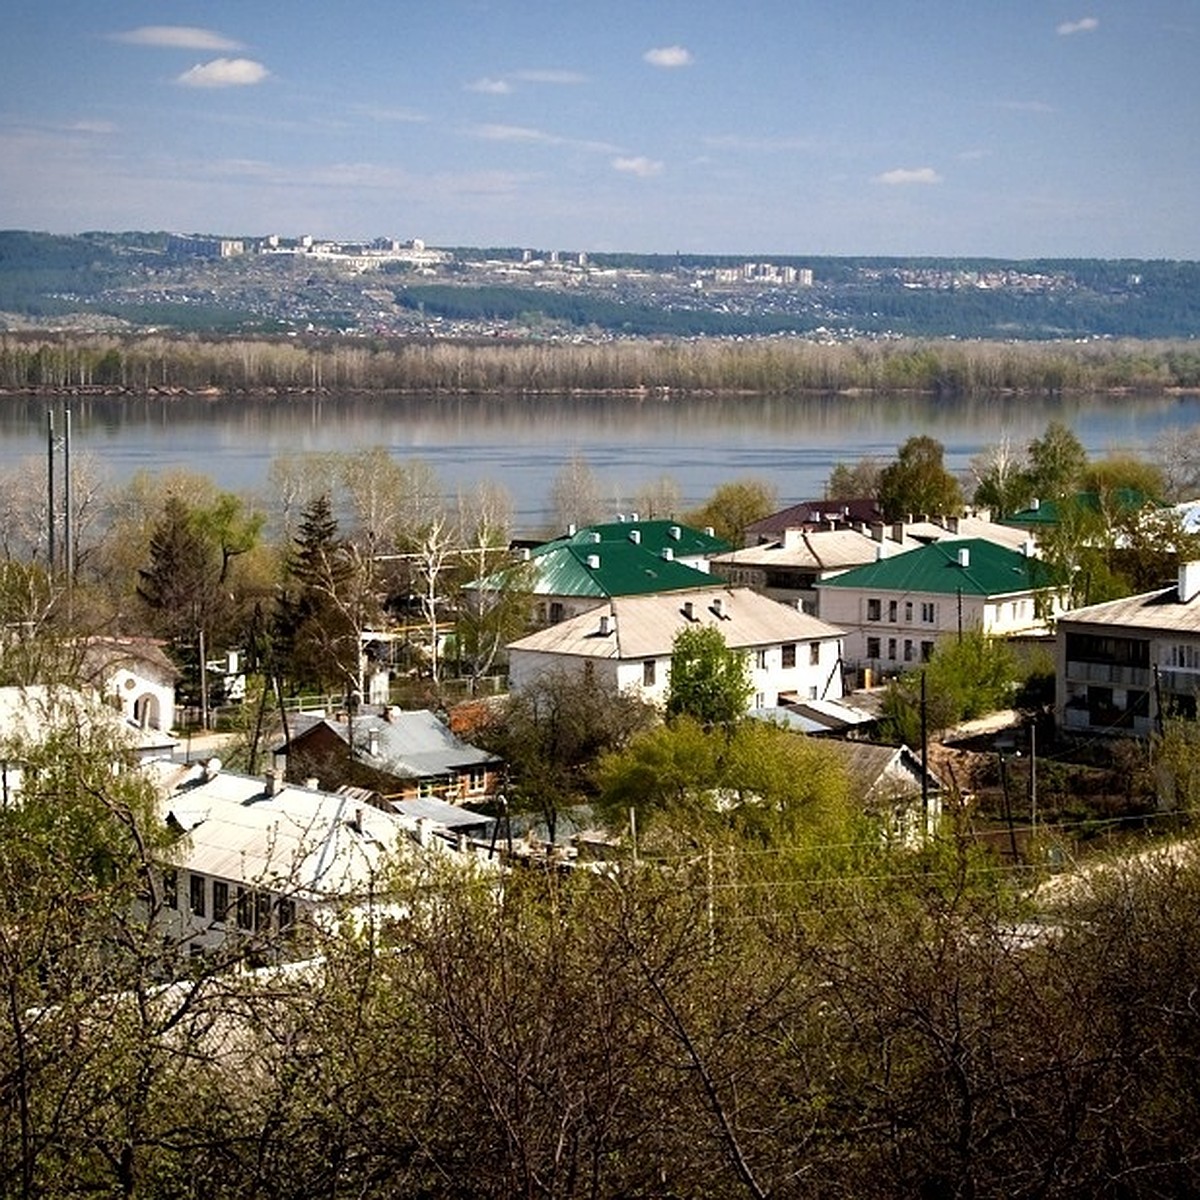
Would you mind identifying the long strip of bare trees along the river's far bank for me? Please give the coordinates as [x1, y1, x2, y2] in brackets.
[7, 334, 1200, 395]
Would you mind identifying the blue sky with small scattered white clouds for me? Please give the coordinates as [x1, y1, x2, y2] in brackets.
[0, 0, 1200, 258]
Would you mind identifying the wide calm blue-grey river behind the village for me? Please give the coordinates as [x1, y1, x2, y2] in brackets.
[0, 395, 1200, 529]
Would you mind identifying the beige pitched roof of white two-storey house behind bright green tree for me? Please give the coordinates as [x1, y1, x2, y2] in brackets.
[509, 581, 842, 660]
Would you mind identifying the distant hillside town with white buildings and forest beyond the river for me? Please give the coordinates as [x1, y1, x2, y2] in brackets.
[0, 232, 1200, 342]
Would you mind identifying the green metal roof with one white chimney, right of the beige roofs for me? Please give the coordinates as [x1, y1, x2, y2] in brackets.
[818, 538, 1062, 596]
